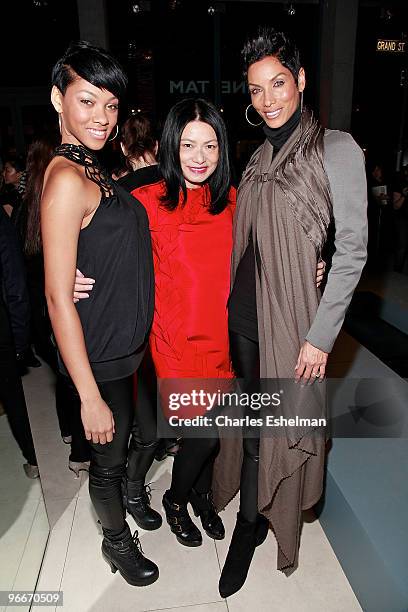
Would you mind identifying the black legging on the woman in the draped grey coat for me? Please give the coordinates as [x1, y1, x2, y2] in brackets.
[229, 330, 259, 522]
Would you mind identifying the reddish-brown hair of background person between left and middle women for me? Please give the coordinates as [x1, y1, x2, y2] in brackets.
[120, 113, 157, 170]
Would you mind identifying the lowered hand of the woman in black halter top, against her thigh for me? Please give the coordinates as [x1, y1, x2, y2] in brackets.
[81, 395, 115, 444]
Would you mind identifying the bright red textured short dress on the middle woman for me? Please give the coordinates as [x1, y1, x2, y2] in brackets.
[132, 182, 236, 378]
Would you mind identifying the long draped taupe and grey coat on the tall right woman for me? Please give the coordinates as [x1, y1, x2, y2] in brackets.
[213, 113, 367, 573]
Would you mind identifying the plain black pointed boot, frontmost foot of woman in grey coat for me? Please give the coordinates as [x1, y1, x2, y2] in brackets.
[219, 512, 258, 597]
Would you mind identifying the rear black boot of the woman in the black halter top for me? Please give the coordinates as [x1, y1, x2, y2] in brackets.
[123, 479, 163, 531]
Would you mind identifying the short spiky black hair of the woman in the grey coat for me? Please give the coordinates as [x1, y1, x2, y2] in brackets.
[241, 26, 302, 83]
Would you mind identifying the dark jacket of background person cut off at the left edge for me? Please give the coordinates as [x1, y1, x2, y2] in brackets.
[0, 208, 30, 353]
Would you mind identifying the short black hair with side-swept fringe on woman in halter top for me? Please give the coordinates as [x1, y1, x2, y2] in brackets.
[51, 40, 128, 100]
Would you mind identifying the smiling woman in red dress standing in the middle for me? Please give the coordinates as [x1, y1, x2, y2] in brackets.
[132, 99, 236, 546]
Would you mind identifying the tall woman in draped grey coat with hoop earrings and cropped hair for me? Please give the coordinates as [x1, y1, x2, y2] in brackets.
[213, 28, 367, 597]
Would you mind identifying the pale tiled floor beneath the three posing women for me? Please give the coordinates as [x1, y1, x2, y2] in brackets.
[20, 366, 361, 612]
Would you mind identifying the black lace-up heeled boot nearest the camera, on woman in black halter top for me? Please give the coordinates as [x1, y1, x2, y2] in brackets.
[102, 523, 159, 586]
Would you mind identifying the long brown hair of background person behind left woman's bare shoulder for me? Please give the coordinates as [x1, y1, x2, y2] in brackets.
[23, 133, 59, 257]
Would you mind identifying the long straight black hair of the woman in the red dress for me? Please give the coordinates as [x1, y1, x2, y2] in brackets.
[159, 98, 231, 215]
